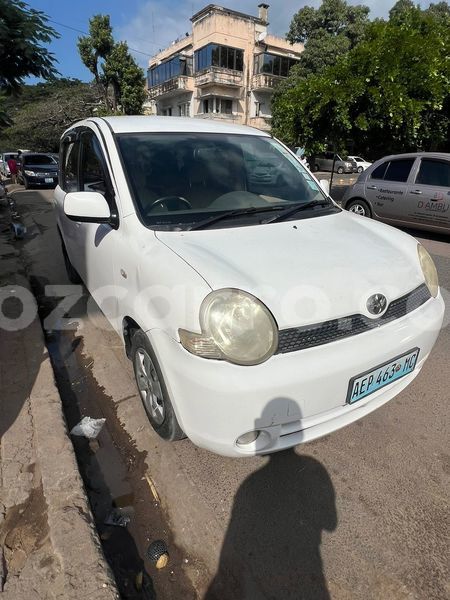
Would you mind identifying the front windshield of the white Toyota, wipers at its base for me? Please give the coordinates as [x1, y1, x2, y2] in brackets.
[117, 133, 339, 230]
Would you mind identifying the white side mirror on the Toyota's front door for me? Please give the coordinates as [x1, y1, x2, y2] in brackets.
[64, 192, 118, 227]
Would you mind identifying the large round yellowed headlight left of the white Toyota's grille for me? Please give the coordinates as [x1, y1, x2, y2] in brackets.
[179, 289, 278, 365]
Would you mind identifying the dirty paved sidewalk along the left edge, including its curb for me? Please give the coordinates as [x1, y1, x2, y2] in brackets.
[0, 196, 118, 600]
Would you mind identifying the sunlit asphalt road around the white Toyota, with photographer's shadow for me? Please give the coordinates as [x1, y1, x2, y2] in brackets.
[8, 191, 450, 600]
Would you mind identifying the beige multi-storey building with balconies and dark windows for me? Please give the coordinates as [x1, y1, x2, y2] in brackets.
[148, 4, 303, 130]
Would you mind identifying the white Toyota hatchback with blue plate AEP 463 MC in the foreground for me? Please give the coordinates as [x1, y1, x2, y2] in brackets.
[55, 117, 444, 456]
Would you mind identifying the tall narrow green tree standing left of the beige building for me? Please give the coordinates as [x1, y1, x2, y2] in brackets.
[78, 15, 146, 114]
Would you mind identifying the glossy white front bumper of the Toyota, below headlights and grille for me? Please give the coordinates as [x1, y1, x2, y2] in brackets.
[147, 295, 444, 456]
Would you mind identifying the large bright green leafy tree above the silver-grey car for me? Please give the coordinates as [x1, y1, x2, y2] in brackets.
[272, 0, 450, 156]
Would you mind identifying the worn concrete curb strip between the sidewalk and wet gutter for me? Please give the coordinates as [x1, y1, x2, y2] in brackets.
[20, 280, 119, 600]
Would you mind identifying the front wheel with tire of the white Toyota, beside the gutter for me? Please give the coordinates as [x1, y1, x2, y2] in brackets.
[130, 329, 186, 442]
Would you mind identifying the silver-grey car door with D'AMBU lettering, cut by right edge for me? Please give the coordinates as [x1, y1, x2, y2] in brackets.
[404, 157, 450, 230]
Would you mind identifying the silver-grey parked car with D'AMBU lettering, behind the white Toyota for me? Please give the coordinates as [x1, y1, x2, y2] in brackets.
[342, 152, 450, 233]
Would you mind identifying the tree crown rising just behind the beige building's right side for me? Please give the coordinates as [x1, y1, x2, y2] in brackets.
[286, 0, 369, 77]
